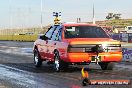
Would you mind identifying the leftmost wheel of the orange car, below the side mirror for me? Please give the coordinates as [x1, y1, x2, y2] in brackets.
[34, 49, 42, 67]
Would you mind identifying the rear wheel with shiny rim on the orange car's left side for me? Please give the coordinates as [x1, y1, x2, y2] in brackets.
[54, 51, 68, 72]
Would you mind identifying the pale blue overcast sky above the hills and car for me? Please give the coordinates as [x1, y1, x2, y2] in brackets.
[0, 0, 132, 28]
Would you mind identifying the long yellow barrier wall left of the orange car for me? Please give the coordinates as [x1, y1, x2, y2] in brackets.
[0, 35, 38, 41]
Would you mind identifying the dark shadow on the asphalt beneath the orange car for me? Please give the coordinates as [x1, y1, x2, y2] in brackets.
[2, 63, 111, 74]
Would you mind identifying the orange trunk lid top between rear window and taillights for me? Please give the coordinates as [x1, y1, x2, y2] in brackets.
[64, 38, 120, 45]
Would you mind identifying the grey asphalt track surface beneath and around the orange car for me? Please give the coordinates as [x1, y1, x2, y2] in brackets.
[0, 41, 132, 88]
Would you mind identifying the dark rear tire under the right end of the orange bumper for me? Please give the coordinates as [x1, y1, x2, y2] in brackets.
[99, 62, 114, 70]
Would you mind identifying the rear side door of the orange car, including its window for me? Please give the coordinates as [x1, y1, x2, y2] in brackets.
[49, 25, 67, 60]
